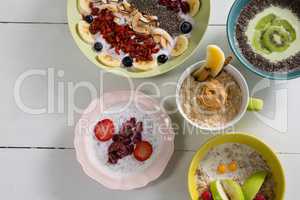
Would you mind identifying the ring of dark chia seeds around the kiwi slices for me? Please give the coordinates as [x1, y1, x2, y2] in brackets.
[236, 0, 300, 73]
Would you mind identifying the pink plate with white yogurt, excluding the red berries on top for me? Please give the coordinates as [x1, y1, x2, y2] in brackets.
[74, 91, 174, 190]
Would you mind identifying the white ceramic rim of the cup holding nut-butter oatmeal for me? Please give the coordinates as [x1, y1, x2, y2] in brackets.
[176, 61, 250, 131]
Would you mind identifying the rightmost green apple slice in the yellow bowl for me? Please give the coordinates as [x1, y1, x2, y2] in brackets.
[242, 171, 268, 200]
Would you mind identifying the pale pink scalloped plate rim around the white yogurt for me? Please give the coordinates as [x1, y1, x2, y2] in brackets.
[74, 91, 175, 190]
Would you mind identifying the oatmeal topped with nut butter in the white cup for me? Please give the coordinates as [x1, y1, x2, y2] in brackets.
[180, 70, 242, 127]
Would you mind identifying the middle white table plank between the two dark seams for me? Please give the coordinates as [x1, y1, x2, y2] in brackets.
[0, 24, 300, 153]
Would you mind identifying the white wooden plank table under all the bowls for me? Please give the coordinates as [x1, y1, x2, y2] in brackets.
[0, 0, 300, 200]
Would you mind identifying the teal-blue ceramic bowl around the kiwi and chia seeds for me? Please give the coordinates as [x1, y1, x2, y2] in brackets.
[227, 0, 300, 80]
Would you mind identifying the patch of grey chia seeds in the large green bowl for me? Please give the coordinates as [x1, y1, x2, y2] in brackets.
[129, 0, 184, 36]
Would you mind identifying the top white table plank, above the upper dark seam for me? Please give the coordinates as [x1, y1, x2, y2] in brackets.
[0, 0, 234, 25]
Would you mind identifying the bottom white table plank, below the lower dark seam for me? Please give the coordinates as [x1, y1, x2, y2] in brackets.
[0, 149, 300, 200]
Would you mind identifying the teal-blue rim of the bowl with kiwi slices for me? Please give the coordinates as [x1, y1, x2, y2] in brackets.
[226, 0, 300, 80]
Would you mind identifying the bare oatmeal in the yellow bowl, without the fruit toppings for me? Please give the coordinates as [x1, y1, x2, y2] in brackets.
[195, 143, 275, 200]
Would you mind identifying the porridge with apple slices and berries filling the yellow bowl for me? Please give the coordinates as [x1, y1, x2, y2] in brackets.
[195, 143, 275, 200]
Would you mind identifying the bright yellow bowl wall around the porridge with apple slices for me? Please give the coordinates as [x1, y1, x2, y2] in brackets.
[188, 133, 285, 200]
